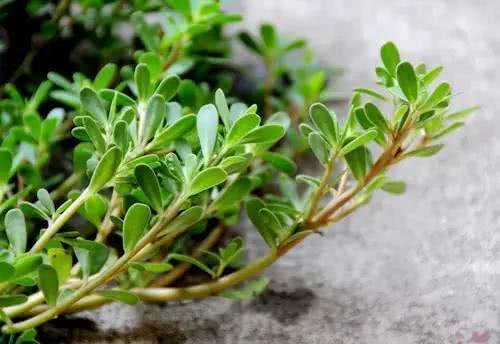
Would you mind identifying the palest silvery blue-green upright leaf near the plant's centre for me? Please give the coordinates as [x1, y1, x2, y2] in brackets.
[196, 104, 219, 165]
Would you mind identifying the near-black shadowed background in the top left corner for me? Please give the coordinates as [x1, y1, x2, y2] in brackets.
[0, 1, 104, 91]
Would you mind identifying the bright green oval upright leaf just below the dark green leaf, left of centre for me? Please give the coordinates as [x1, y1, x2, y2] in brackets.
[123, 203, 151, 253]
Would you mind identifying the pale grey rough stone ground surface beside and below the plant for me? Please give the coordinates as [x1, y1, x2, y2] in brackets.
[53, 0, 500, 344]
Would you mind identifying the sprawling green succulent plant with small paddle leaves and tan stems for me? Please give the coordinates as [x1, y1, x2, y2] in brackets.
[0, 1, 473, 343]
